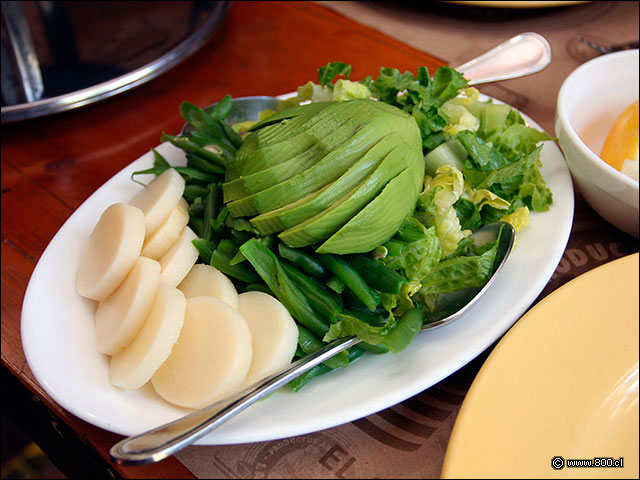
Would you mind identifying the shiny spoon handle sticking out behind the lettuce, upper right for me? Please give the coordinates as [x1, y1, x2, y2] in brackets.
[456, 32, 551, 85]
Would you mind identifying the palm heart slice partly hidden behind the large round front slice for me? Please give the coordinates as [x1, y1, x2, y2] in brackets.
[178, 263, 238, 310]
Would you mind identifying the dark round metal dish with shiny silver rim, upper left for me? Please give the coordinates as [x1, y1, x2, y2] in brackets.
[2, 1, 231, 124]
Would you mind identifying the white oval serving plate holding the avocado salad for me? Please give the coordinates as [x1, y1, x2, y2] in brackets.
[21, 97, 574, 445]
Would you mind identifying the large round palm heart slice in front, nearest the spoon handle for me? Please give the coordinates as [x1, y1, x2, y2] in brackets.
[151, 297, 252, 408]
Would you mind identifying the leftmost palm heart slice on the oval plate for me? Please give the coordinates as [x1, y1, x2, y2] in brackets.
[76, 203, 144, 301]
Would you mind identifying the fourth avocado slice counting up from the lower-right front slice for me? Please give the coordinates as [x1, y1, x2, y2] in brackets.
[227, 112, 388, 217]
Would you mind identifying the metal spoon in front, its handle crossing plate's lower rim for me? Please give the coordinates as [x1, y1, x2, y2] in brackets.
[109, 222, 515, 465]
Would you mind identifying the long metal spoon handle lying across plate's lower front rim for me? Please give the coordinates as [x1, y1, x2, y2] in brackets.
[109, 337, 361, 465]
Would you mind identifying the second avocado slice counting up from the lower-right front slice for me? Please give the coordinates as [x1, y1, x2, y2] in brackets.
[278, 142, 411, 247]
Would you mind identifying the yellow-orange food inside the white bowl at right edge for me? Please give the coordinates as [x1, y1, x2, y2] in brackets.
[600, 100, 638, 180]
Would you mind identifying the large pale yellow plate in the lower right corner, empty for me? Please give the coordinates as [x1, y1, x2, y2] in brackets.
[442, 253, 639, 478]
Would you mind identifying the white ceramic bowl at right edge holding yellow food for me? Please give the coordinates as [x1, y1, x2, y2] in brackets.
[555, 50, 638, 237]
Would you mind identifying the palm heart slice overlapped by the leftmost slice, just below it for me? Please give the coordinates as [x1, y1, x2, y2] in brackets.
[95, 257, 160, 355]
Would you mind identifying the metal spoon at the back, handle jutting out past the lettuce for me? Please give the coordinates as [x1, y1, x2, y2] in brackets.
[181, 32, 551, 135]
